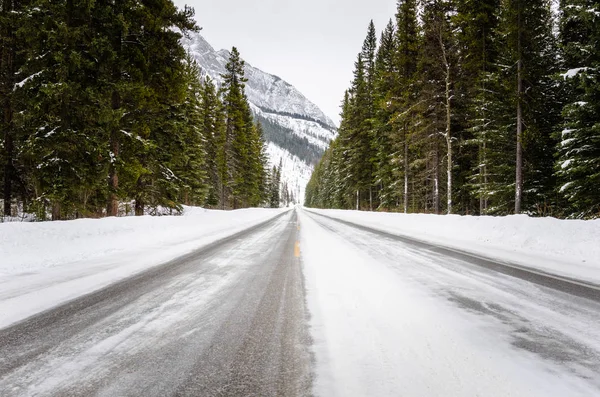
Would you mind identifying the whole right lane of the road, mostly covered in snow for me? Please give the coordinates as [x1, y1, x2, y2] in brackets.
[299, 211, 600, 397]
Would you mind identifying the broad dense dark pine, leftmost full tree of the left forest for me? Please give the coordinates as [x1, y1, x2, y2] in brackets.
[21, 0, 106, 219]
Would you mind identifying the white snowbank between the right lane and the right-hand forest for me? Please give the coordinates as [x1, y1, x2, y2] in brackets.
[307, 209, 600, 284]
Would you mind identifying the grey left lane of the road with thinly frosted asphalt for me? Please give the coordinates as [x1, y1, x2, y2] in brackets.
[0, 212, 311, 397]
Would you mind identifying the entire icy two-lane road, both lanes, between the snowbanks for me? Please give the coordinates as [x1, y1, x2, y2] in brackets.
[0, 209, 600, 397]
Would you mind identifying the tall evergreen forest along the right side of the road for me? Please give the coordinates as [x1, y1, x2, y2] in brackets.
[306, 0, 600, 218]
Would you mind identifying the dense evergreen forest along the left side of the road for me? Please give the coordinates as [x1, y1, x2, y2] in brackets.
[0, 0, 282, 220]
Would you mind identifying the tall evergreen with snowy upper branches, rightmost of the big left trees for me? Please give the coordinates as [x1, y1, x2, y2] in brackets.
[123, 0, 196, 215]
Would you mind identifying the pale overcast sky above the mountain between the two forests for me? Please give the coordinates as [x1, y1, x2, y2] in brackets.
[175, 0, 396, 123]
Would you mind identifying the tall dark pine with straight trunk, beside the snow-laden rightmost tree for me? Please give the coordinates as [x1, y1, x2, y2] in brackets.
[490, 0, 560, 213]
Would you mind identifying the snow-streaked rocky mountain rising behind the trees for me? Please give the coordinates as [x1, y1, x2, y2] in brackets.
[182, 33, 337, 200]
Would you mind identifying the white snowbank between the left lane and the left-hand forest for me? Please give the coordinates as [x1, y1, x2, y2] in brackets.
[0, 208, 283, 328]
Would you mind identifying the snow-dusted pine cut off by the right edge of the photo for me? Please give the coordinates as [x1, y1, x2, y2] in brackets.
[556, 0, 600, 217]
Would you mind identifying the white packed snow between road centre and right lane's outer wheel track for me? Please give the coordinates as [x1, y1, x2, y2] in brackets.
[300, 211, 593, 397]
